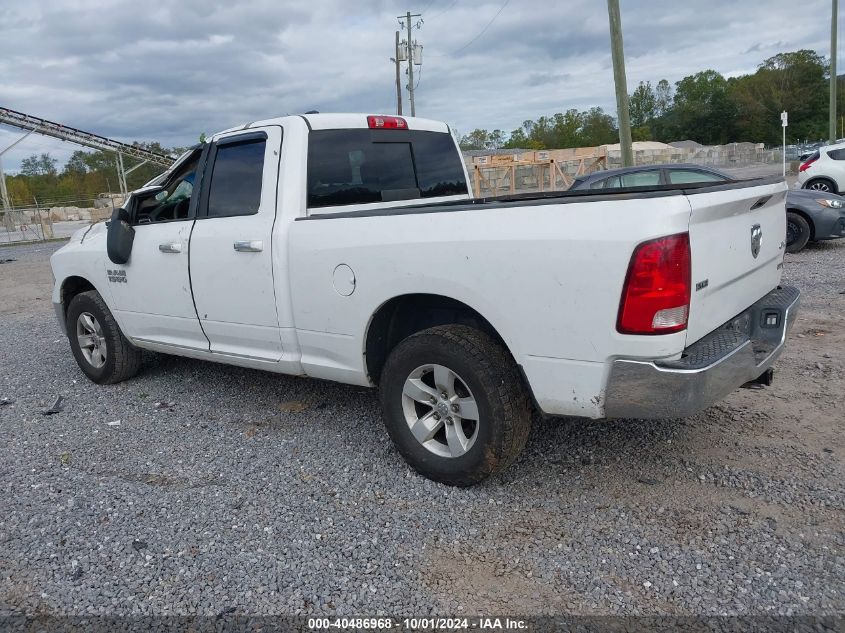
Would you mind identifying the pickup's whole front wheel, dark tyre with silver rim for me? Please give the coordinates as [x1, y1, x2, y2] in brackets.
[67, 290, 141, 385]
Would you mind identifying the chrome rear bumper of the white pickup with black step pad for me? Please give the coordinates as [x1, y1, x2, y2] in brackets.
[605, 287, 801, 418]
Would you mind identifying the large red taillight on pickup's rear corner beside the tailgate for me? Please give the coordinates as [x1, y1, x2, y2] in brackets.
[616, 233, 691, 334]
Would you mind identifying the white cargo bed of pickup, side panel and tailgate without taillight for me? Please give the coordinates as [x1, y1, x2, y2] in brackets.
[289, 178, 787, 417]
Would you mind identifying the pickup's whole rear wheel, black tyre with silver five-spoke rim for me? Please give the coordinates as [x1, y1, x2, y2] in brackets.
[380, 325, 531, 486]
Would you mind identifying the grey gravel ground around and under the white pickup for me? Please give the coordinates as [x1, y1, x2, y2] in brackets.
[0, 240, 845, 615]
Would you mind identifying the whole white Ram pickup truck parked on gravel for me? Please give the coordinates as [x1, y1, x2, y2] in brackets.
[51, 114, 799, 485]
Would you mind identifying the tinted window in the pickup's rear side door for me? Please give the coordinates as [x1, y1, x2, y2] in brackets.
[208, 139, 266, 217]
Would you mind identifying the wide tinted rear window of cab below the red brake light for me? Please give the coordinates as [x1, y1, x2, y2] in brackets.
[308, 129, 467, 208]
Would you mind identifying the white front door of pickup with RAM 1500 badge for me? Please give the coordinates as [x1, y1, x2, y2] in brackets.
[105, 150, 208, 349]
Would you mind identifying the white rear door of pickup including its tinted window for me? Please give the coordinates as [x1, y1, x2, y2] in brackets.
[190, 126, 282, 361]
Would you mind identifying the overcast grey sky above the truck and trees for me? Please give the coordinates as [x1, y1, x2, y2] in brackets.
[0, 0, 831, 172]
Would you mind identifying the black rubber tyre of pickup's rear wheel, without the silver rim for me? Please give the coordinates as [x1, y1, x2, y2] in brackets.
[379, 325, 532, 486]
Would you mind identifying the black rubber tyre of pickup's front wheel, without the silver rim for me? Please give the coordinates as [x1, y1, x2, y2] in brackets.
[67, 290, 141, 385]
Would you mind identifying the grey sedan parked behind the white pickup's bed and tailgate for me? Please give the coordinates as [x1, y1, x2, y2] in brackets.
[570, 163, 845, 253]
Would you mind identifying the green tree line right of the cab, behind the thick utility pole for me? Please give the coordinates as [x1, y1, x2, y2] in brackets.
[460, 50, 845, 150]
